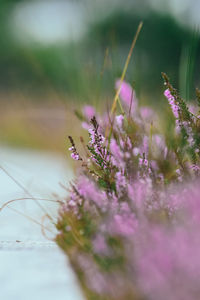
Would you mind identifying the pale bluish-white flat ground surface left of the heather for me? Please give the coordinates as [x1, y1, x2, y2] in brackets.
[0, 147, 84, 300]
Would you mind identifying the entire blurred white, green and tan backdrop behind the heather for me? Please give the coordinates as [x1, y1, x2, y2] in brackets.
[0, 0, 200, 153]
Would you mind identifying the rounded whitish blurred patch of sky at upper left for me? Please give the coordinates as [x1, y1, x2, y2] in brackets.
[10, 0, 85, 44]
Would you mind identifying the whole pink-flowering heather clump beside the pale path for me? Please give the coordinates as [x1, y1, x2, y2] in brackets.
[56, 74, 200, 300]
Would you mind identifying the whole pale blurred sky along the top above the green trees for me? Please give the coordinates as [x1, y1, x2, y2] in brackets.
[9, 0, 200, 44]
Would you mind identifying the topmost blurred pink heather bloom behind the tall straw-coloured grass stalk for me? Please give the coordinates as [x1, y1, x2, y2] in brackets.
[115, 79, 137, 111]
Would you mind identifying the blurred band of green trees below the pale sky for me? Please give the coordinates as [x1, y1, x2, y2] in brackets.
[0, 0, 200, 102]
